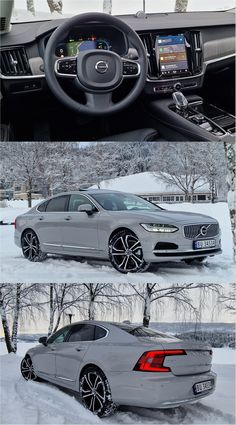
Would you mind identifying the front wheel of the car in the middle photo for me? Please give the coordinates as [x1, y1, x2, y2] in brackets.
[108, 230, 150, 273]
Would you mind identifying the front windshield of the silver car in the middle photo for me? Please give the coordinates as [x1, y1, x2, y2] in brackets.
[92, 193, 162, 211]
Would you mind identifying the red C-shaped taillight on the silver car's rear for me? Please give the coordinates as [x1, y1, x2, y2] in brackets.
[134, 350, 186, 372]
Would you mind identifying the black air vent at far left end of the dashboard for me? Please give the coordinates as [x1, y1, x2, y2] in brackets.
[0, 47, 32, 77]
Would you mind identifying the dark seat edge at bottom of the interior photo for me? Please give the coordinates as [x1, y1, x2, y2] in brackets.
[100, 128, 160, 142]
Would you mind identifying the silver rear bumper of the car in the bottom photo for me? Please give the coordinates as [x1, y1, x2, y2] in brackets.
[109, 371, 216, 409]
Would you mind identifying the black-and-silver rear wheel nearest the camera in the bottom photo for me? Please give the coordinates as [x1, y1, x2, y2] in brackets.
[79, 366, 117, 417]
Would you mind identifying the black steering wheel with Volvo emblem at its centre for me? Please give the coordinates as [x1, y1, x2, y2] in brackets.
[44, 13, 148, 115]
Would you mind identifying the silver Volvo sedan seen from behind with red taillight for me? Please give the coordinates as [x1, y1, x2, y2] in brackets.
[21, 321, 216, 416]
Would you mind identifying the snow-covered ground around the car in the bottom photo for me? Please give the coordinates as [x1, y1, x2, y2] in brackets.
[0, 343, 235, 425]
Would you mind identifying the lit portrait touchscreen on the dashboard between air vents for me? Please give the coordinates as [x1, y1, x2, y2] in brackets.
[155, 34, 189, 76]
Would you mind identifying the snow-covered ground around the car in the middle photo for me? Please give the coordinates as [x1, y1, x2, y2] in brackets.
[0, 201, 236, 283]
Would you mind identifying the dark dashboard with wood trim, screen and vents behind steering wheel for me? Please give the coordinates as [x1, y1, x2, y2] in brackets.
[0, 11, 235, 95]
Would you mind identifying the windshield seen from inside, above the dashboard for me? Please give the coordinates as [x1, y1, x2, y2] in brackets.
[12, 0, 235, 23]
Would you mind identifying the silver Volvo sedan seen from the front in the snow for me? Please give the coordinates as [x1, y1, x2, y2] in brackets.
[15, 189, 221, 273]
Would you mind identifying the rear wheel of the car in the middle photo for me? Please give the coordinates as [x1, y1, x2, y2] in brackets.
[21, 229, 47, 262]
